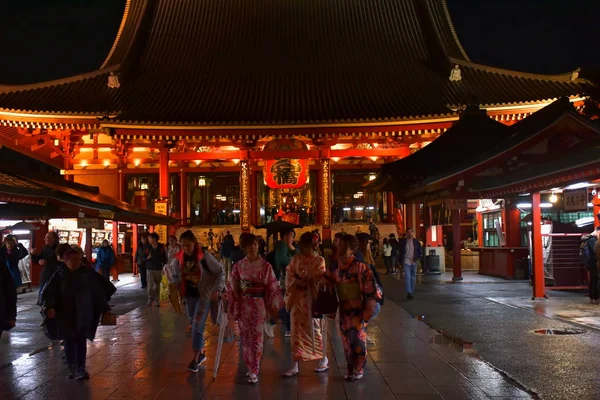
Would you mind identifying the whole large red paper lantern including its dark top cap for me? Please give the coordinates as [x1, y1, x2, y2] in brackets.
[263, 139, 308, 189]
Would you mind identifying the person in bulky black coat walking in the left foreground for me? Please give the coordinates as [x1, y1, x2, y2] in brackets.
[42, 249, 109, 380]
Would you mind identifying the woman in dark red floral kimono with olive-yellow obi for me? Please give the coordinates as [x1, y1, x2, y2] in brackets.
[328, 235, 381, 380]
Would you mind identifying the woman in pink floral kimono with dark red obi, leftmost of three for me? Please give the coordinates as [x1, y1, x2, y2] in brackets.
[227, 234, 283, 384]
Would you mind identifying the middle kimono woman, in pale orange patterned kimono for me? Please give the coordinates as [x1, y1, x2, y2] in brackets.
[283, 232, 329, 378]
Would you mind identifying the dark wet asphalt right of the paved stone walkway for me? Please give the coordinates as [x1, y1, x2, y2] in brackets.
[383, 274, 600, 399]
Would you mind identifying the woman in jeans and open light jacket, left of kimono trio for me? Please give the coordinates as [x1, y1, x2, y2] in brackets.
[173, 230, 225, 372]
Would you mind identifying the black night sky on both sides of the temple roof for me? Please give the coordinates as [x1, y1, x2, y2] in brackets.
[0, 0, 600, 84]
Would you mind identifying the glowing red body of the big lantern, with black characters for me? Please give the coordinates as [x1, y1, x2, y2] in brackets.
[264, 158, 308, 189]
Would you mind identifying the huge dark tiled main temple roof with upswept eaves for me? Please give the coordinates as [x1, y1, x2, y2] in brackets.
[0, 0, 589, 125]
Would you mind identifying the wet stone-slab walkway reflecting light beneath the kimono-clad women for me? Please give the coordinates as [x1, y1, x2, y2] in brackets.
[0, 270, 531, 400]
